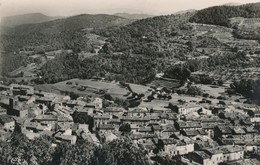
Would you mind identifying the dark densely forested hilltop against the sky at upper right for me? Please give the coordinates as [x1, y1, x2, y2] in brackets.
[190, 3, 260, 26]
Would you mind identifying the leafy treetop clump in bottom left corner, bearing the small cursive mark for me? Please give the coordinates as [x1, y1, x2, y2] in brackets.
[0, 133, 55, 165]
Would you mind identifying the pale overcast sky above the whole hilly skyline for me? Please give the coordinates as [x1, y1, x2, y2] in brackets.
[0, 0, 260, 16]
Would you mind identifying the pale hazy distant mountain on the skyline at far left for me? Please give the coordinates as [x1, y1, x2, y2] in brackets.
[1, 13, 63, 27]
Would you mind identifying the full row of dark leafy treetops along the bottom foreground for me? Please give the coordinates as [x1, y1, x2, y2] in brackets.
[0, 134, 154, 165]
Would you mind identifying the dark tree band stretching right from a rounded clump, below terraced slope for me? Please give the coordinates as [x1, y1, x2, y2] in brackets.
[164, 52, 254, 85]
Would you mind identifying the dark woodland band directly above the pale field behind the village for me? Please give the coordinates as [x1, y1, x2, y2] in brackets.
[36, 54, 156, 83]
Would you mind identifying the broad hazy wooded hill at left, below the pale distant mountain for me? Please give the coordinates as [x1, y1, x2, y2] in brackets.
[1, 14, 132, 52]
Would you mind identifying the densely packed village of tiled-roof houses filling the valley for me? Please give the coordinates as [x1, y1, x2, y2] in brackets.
[0, 77, 260, 165]
